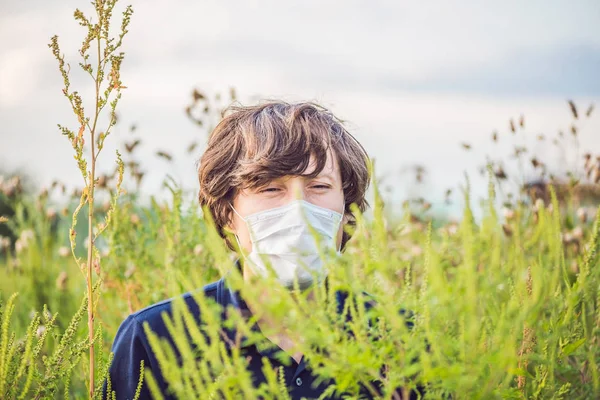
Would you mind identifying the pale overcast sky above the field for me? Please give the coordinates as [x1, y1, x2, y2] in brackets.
[0, 0, 600, 216]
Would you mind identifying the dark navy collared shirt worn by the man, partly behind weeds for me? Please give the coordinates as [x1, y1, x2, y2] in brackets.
[105, 279, 412, 400]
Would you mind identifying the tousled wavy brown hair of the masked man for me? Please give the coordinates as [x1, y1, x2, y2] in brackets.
[198, 101, 370, 250]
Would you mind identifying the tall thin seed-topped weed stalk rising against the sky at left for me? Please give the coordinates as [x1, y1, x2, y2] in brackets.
[49, 0, 133, 397]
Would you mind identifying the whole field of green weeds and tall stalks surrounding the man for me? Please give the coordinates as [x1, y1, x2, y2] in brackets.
[0, 0, 600, 399]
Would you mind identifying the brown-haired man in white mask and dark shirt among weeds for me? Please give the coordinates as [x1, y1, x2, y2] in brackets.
[110, 102, 412, 399]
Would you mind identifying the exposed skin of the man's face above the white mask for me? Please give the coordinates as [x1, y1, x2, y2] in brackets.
[230, 151, 346, 253]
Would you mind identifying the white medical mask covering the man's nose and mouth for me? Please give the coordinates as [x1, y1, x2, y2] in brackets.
[231, 200, 342, 290]
